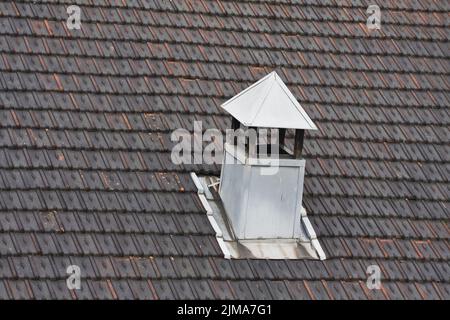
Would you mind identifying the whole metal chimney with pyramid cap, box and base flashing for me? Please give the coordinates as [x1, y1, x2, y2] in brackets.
[191, 72, 325, 259]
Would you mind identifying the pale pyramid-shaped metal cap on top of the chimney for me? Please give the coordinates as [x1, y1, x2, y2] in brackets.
[222, 71, 317, 130]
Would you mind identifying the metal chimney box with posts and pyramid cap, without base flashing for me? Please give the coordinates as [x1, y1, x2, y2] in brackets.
[219, 72, 317, 240]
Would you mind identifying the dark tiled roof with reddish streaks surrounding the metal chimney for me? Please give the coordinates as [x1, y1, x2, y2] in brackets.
[0, 0, 450, 299]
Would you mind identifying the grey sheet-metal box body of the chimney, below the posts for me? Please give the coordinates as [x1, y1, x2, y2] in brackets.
[219, 145, 305, 240]
